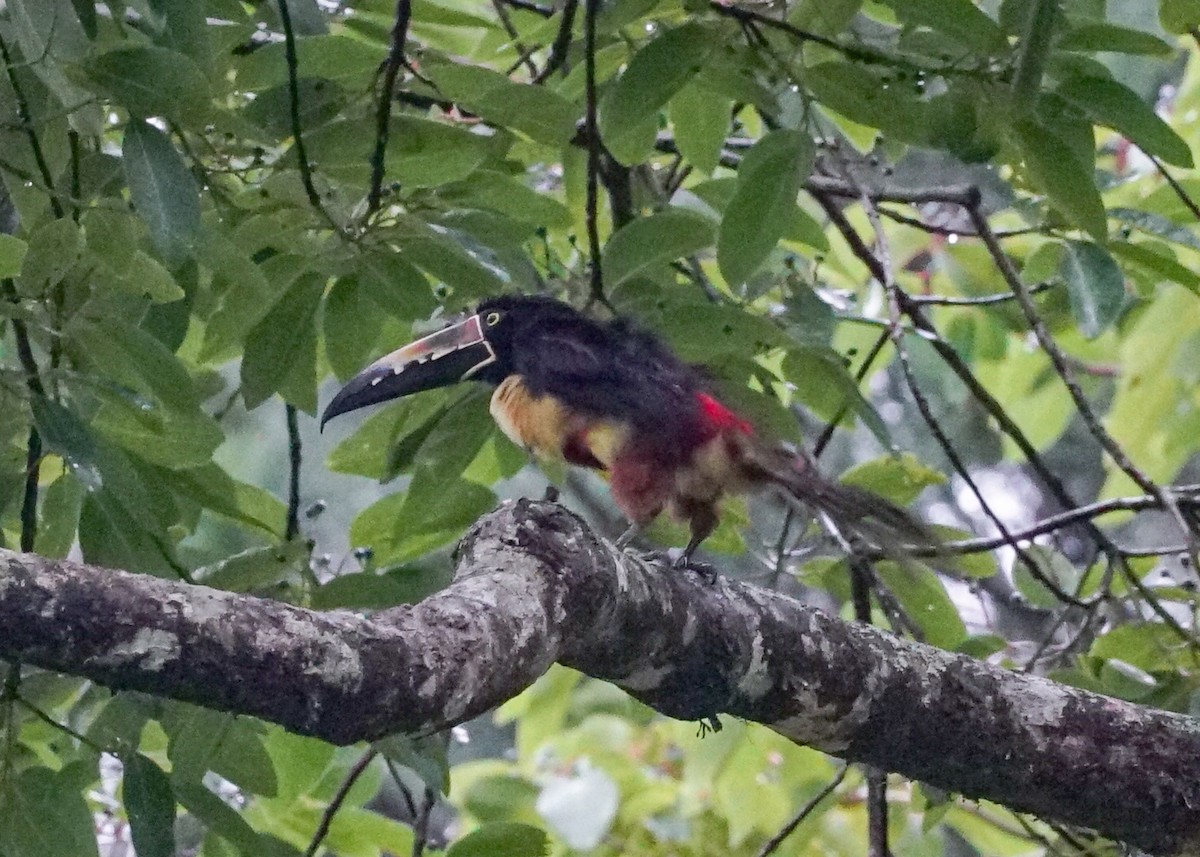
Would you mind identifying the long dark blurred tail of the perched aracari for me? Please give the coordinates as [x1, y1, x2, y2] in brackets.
[743, 444, 940, 559]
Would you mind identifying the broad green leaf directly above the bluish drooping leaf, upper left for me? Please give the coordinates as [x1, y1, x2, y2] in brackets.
[83, 44, 211, 119]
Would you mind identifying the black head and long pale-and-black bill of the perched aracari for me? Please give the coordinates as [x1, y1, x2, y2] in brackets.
[320, 295, 595, 426]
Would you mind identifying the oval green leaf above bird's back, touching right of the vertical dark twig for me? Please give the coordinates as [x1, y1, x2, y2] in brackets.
[601, 209, 714, 288]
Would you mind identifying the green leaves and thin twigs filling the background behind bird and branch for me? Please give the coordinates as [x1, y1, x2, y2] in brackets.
[0, 0, 1200, 857]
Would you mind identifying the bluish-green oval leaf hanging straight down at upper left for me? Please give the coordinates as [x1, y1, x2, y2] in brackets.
[121, 120, 200, 265]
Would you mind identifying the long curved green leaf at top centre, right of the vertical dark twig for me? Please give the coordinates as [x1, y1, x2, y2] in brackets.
[599, 23, 720, 166]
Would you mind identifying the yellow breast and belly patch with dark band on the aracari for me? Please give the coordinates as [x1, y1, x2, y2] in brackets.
[490, 374, 628, 468]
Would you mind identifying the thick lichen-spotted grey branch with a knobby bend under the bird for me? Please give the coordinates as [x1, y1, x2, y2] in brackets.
[0, 501, 1200, 853]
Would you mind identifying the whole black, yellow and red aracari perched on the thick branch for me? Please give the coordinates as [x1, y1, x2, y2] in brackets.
[322, 296, 934, 565]
